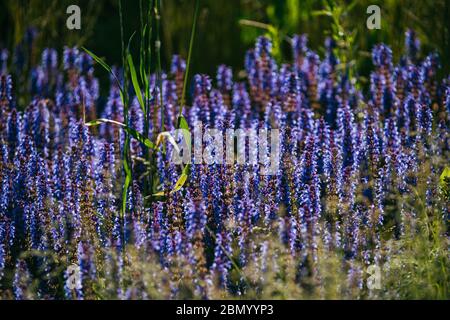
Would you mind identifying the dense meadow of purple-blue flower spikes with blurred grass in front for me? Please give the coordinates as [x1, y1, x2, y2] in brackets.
[0, 27, 450, 299]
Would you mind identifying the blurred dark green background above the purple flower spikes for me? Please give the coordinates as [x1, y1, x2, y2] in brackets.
[0, 0, 450, 79]
